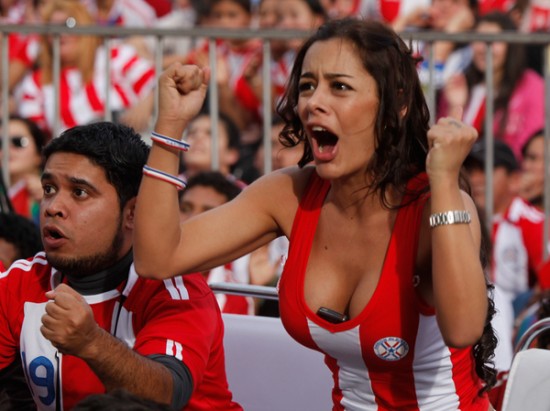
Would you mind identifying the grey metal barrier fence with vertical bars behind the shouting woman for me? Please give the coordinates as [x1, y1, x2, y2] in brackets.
[0, 24, 550, 258]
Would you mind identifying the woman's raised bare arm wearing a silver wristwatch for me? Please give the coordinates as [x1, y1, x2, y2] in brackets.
[422, 112, 487, 347]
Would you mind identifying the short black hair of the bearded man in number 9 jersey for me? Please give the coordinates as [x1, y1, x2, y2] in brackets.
[43, 121, 149, 209]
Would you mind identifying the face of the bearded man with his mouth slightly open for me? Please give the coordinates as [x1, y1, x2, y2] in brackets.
[40, 152, 131, 277]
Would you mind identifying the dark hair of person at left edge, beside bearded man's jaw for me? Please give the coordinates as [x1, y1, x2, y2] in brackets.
[0, 213, 44, 260]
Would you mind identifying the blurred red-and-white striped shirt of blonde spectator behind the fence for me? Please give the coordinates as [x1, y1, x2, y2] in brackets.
[15, 44, 155, 134]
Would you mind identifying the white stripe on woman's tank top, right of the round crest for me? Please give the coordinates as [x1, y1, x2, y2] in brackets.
[413, 315, 460, 411]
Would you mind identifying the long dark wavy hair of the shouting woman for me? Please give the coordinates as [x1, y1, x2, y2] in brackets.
[277, 19, 496, 392]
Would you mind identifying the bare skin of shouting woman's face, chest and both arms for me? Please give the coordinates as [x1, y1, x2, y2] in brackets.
[134, 40, 487, 347]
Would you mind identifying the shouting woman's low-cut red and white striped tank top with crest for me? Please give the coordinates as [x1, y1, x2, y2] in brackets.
[279, 172, 489, 411]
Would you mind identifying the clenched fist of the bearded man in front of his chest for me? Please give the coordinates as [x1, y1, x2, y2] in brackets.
[40, 284, 102, 358]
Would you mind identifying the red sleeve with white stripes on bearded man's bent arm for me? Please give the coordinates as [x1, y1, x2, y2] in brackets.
[134, 276, 223, 387]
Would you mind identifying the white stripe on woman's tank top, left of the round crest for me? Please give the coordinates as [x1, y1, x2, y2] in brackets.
[307, 319, 378, 411]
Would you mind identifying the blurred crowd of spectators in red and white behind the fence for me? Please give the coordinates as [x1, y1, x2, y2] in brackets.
[0, 0, 550, 400]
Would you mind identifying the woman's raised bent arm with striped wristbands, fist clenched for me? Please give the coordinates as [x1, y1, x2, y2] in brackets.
[134, 64, 286, 279]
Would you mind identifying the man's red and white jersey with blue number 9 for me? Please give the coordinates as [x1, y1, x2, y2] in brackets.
[0, 252, 241, 411]
